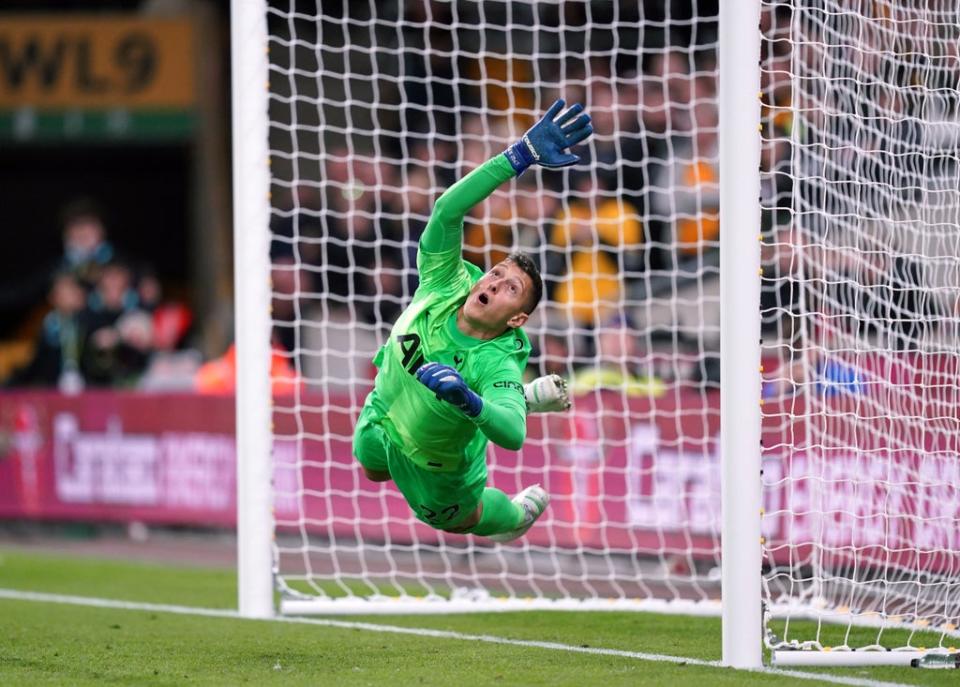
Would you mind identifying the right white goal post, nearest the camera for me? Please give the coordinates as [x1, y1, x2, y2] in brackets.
[720, 0, 763, 668]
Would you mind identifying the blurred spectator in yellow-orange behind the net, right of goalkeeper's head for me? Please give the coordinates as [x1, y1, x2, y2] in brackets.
[546, 174, 644, 327]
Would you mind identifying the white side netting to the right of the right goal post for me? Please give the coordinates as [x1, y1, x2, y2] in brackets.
[761, 0, 960, 649]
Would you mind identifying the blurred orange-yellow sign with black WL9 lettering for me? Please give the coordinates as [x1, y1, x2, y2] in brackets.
[0, 14, 196, 109]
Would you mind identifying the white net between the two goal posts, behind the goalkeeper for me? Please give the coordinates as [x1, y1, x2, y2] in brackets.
[269, 2, 719, 612]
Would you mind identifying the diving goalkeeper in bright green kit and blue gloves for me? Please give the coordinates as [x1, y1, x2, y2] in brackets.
[353, 100, 593, 541]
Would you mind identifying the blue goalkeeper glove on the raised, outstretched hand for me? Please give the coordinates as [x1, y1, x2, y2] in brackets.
[503, 100, 593, 176]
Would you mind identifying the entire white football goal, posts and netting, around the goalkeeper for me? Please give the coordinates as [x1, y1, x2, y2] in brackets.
[231, 0, 960, 667]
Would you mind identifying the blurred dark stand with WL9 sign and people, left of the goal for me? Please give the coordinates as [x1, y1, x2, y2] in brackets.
[0, 0, 232, 392]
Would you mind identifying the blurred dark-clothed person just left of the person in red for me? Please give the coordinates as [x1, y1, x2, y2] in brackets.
[81, 262, 153, 386]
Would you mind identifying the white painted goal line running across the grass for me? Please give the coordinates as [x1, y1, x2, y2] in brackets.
[0, 588, 910, 687]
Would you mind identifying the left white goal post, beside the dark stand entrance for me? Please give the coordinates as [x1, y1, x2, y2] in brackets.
[230, 0, 274, 618]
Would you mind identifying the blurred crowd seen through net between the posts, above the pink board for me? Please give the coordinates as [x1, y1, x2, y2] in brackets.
[270, 2, 732, 395]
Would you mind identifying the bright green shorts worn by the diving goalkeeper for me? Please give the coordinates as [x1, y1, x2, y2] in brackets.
[353, 391, 487, 530]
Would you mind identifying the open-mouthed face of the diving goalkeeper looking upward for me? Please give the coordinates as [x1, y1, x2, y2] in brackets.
[463, 260, 533, 332]
